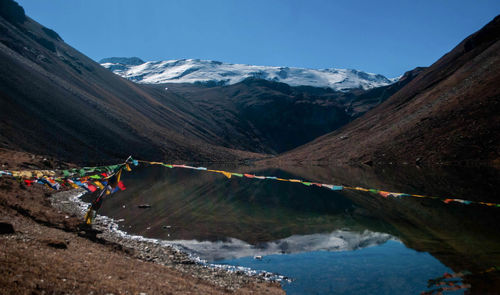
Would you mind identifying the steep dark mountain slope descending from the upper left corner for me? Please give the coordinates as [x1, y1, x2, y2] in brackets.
[0, 0, 268, 163]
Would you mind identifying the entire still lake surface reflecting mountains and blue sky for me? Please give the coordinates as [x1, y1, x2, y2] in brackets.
[88, 166, 500, 294]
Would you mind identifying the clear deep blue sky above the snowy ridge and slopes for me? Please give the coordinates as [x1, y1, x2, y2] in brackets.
[17, 0, 500, 77]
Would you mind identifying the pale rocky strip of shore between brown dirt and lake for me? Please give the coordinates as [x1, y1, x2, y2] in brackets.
[50, 189, 288, 291]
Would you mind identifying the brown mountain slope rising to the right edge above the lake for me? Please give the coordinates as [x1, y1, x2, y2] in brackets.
[276, 16, 500, 165]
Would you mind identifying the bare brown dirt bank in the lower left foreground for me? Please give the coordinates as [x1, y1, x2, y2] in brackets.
[0, 149, 285, 294]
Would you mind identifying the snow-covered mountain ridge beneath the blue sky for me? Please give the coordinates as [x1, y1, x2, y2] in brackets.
[101, 58, 394, 90]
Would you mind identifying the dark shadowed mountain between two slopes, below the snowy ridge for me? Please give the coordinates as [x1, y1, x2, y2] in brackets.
[161, 71, 418, 154]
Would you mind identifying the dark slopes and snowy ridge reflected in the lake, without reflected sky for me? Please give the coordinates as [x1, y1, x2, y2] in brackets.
[90, 166, 500, 294]
